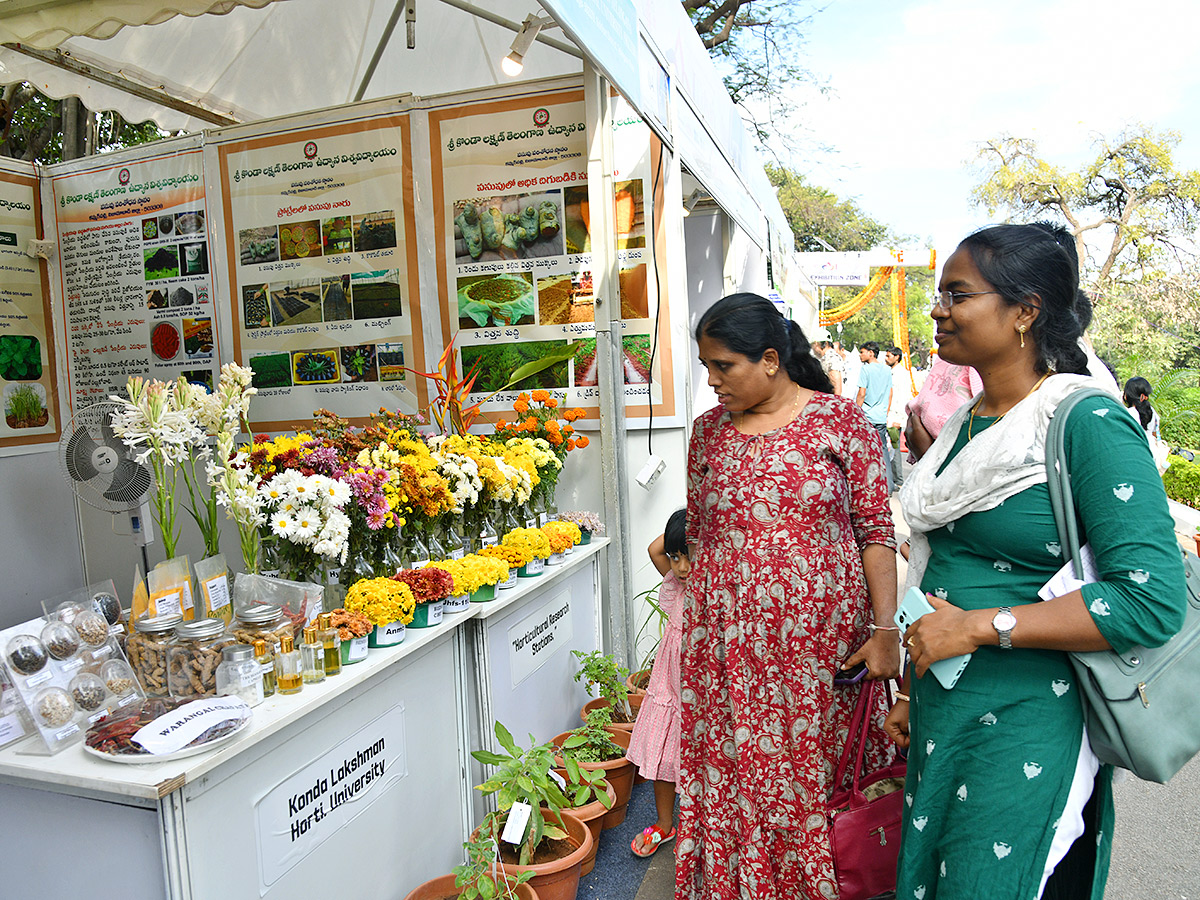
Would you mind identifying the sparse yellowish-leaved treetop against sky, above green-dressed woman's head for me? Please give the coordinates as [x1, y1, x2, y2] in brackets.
[973, 126, 1200, 296]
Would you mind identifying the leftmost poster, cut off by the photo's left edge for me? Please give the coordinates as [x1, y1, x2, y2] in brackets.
[0, 167, 61, 454]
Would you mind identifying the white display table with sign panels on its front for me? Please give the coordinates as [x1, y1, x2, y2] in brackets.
[0, 540, 605, 900]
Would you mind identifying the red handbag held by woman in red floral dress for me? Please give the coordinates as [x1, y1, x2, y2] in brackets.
[827, 682, 907, 900]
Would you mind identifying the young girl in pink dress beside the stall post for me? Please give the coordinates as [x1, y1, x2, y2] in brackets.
[625, 510, 691, 857]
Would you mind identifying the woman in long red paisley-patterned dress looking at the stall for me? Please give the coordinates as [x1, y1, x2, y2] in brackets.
[676, 294, 900, 900]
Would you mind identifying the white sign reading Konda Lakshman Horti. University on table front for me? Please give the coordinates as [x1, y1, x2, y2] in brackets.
[254, 703, 408, 894]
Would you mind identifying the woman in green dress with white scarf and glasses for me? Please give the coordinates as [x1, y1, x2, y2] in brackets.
[886, 224, 1186, 900]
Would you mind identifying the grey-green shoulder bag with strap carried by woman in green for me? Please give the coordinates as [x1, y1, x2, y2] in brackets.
[1046, 388, 1200, 784]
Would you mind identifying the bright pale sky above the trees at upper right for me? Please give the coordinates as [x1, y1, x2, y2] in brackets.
[792, 0, 1200, 260]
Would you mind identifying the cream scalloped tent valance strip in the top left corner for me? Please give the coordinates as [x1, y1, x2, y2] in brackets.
[0, 0, 284, 49]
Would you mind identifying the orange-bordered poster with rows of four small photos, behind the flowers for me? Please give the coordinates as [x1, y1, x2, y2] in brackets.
[217, 107, 426, 431]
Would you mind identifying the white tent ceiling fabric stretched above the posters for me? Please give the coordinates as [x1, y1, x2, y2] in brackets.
[0, 0, 582, 131]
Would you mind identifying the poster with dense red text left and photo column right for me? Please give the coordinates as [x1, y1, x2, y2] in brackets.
[50, 136, 221, 412]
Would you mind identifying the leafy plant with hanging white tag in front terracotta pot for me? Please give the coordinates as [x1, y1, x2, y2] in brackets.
[472, 722, 592, 900]
